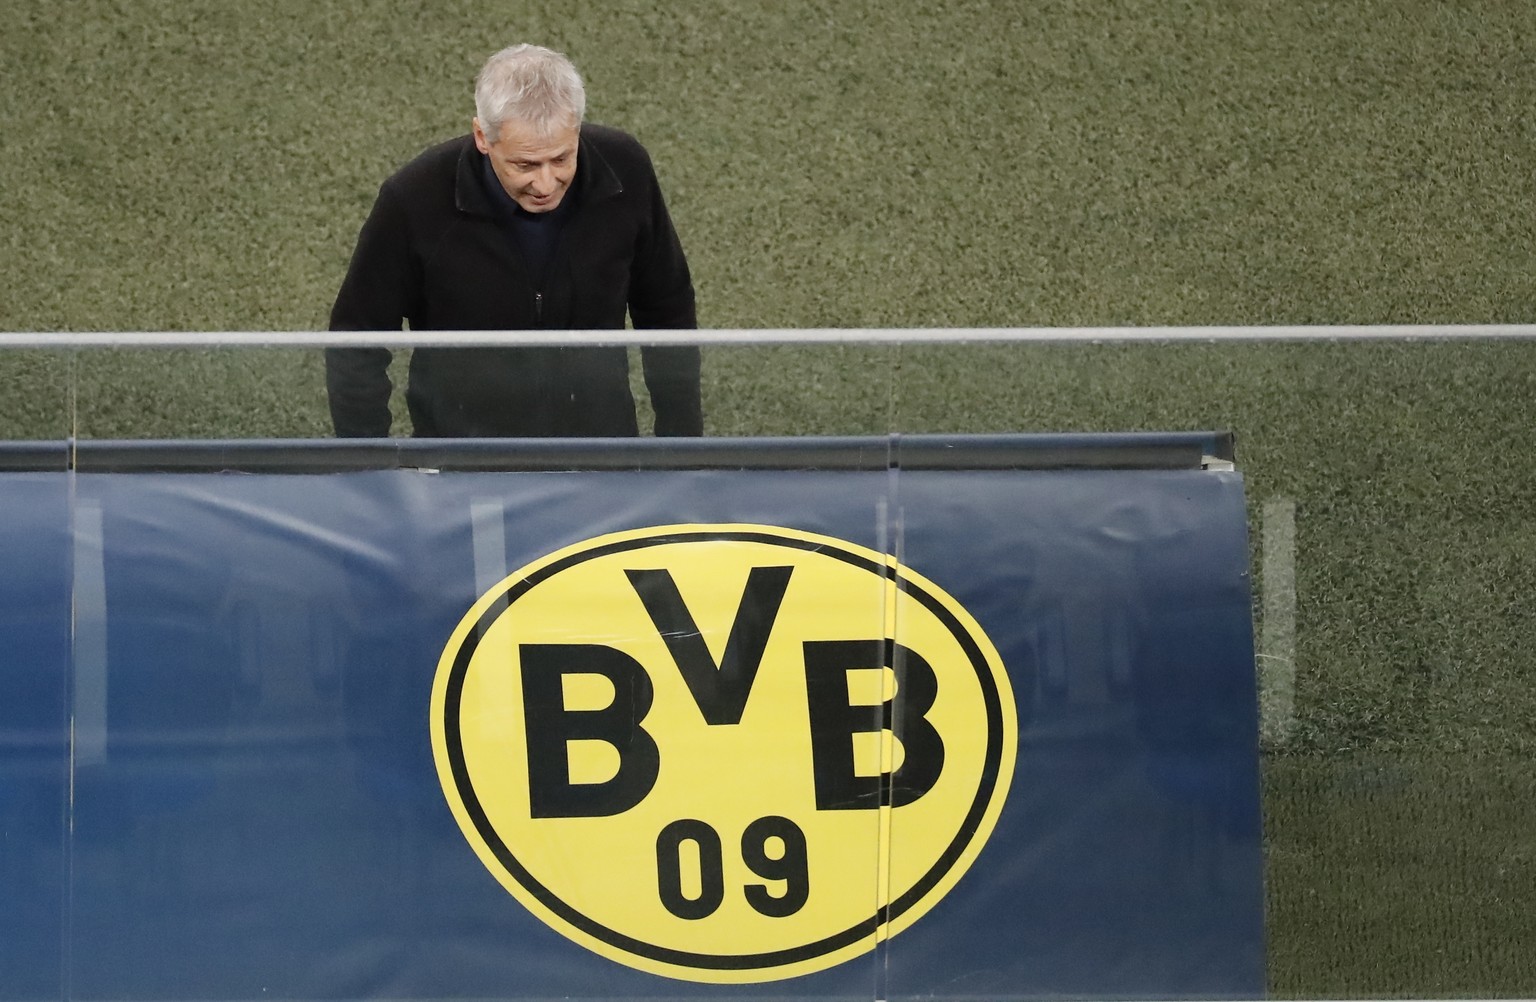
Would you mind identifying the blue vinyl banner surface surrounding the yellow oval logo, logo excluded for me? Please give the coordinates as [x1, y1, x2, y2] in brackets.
[0, 454, 1264, 1000]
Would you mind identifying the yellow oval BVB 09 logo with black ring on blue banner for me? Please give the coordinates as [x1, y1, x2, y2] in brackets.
[432, 526, 1018, 984]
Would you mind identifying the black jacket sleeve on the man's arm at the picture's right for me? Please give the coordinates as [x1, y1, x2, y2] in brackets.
[630, 164, 703, 436]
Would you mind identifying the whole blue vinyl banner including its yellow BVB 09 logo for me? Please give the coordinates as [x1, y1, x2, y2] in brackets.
[0, 436, 1264, 1000]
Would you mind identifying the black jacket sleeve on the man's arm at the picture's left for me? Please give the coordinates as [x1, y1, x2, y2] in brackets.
[326, 187, 415, 438]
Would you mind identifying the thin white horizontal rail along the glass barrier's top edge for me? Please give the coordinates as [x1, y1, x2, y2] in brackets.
[0, 324, 1536, 349]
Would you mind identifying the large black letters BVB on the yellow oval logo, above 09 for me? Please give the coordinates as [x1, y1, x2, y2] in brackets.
[518, 567, 945, 817]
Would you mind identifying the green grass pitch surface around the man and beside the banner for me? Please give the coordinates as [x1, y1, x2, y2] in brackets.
[0, 0, 1536, 997]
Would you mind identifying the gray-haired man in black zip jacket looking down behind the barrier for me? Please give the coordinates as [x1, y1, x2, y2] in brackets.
[326, 45, 703, 436]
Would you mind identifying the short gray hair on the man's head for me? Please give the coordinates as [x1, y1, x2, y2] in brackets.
[475, 45, 587, 143]
